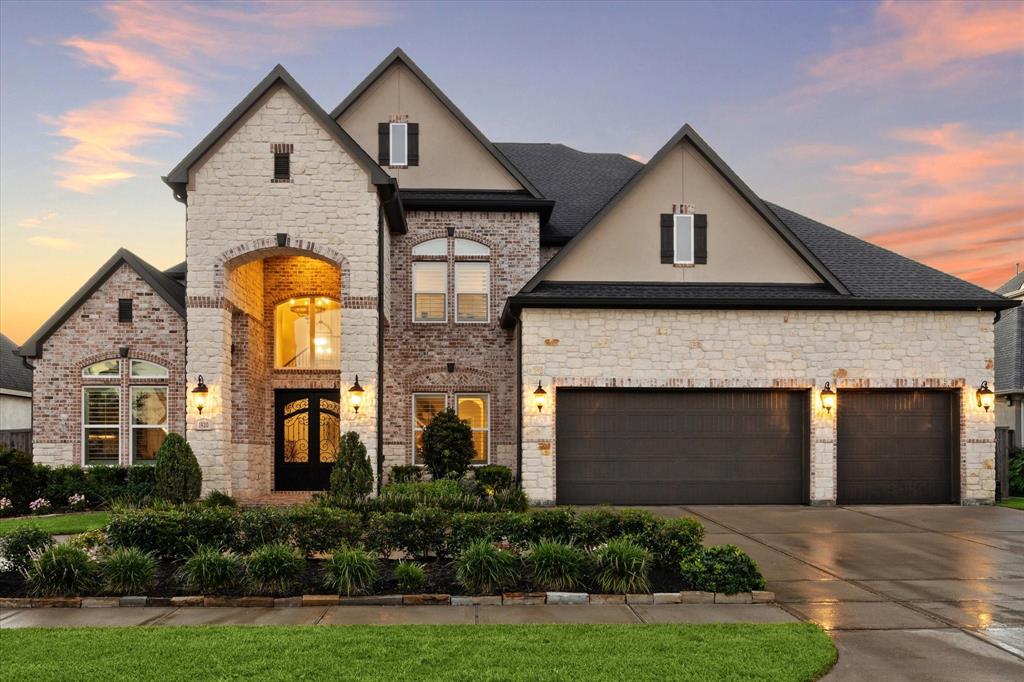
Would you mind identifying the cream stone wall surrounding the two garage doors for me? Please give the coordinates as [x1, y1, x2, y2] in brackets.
[521, 308, 995, 504]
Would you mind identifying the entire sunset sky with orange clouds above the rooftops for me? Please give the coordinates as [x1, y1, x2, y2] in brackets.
[0, 0, 1024, 342]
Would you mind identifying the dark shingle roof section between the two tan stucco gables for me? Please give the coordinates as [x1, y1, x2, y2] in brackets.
[495, 142, 643, 244]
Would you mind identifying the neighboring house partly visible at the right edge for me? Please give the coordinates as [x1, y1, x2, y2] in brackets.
[995, 272, 1024, 447]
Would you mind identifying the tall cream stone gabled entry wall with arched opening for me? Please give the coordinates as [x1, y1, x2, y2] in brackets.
[185, 86, 378, 495]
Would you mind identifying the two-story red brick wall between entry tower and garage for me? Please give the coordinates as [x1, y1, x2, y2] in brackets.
[384, 211, 539, 475]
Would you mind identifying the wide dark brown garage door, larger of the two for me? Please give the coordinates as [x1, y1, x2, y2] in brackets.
[555, 389, 808, 505]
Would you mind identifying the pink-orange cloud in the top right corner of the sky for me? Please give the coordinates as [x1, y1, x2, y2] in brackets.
[801, 0, 1024, 95]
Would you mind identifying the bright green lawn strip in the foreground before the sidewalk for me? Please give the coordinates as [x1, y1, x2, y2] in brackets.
[0, 622, 836, 682]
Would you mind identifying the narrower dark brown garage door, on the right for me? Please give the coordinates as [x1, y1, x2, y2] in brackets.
[837, 390, 959, 504]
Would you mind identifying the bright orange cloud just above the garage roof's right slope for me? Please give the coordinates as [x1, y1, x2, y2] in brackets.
[840, 124, 1024, 288]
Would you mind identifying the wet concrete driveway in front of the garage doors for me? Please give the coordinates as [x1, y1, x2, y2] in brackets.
[671, 506, 1024, 682]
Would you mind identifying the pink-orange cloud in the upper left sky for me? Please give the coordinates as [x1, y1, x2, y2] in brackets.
[49, 1, 384, 193]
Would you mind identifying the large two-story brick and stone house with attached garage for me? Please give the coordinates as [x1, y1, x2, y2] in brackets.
[12, 50, 1015, 504]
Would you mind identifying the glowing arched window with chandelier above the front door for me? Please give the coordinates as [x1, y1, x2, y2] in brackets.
[273, 296, 341, 370]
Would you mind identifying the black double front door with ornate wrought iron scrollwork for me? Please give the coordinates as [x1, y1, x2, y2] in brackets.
[273, 389, 341, 491]
